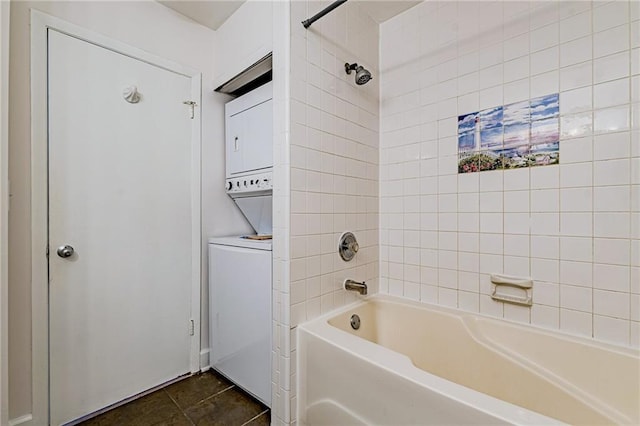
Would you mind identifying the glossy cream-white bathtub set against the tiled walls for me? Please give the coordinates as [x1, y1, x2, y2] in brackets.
[296, 295, 640, 426]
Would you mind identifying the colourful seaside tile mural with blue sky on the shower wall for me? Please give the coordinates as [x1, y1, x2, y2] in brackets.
[458, 93, 560, 173]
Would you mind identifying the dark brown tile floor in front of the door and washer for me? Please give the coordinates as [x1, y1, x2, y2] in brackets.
[81, 371, 271, 426]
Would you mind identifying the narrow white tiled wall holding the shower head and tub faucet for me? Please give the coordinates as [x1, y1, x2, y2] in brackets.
[286, 1, 380, 424]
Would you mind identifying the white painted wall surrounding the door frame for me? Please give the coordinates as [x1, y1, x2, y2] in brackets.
[8, 1, 250, 418]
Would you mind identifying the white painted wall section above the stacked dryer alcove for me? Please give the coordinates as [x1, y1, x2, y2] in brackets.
[213, 0, 273, 87]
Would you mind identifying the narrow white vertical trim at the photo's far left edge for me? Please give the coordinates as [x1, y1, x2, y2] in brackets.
[0, 1, 11, 425]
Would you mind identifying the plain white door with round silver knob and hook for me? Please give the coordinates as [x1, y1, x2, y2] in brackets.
[48, 30, 199, 425]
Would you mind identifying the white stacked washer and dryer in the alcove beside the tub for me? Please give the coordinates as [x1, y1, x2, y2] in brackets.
[209, 82, 273, 406]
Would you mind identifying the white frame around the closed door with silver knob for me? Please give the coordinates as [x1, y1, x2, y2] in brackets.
[31, 9, 202, 425]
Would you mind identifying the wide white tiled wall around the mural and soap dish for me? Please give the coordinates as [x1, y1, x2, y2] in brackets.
[380, 1, 640, 346]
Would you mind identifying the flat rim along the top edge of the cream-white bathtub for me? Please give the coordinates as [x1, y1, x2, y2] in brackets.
[296, 293, 640, 425]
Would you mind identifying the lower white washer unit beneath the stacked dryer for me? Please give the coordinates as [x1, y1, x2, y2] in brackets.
[209, 237, 271, 407]
